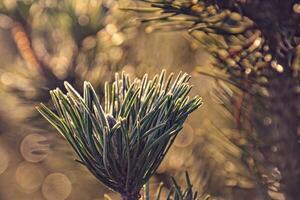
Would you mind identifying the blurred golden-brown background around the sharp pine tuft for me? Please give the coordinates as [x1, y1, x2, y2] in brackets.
[0, 0, 298, 200]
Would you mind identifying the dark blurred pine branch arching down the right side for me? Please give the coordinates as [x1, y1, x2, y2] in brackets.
[123, 0, 300, 199]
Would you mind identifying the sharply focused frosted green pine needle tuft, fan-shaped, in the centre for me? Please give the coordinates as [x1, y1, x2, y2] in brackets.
[37, 71, 202, 199]
